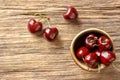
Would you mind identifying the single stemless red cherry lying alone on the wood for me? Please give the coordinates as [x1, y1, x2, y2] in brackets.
[63, 6, 78, 20]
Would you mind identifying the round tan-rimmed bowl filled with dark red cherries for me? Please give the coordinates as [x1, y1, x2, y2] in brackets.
[70, 28, 116, 71]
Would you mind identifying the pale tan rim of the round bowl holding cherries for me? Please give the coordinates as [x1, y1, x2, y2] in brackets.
[70, 28, 114, 72]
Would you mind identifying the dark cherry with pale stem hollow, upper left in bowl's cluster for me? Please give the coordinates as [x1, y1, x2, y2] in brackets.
[85, 34, 97, 48]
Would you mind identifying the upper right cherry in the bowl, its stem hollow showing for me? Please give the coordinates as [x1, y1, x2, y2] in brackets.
[98, 36, 112, 50]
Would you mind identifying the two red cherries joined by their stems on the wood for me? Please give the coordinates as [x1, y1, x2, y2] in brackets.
[28, 19, 58, 41]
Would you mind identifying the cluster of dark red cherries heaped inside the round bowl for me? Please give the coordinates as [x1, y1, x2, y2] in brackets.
[76, 34, 116, 68]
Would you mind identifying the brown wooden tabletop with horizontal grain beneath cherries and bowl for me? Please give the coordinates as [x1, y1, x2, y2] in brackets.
[0, 0, 120, 80]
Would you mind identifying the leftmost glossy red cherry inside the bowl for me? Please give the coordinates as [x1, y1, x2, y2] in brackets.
[76, 47, 89, 59]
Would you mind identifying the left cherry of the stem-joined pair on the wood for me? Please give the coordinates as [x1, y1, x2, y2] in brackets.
[28, 19, 42, 33]
